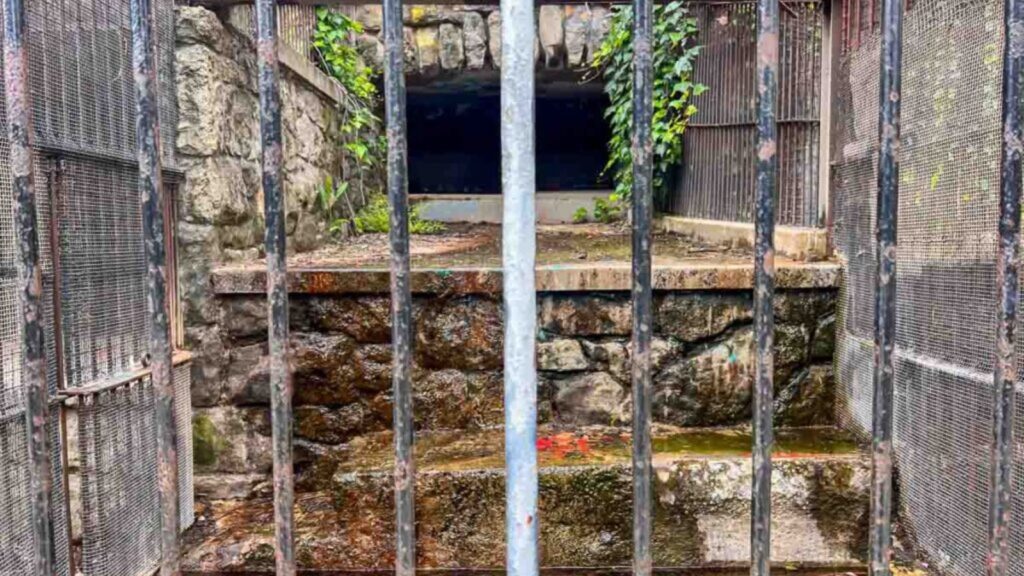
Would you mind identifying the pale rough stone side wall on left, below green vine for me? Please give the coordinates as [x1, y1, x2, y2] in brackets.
[175, 6, 379, 393]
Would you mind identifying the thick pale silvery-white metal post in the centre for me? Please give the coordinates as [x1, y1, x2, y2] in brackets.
[501, 0, 540, 576]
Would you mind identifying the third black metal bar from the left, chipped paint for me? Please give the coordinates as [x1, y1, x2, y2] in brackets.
[256, 0, 295, 576]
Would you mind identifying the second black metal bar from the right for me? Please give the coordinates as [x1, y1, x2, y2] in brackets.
[868, 0, 903, 576]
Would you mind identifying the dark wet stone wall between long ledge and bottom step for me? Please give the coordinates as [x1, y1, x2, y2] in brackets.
[193, 289, 836, 498]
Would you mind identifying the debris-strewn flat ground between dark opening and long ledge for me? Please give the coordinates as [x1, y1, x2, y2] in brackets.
[270, 223, 753, 269]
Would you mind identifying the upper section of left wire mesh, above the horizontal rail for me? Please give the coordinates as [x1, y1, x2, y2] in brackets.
[27, 0, 177, 166]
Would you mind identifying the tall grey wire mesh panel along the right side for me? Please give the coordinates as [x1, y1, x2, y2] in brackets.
[833, 0, 1024, 575]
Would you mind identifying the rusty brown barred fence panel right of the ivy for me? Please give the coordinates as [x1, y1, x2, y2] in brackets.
[668, 2, 821, 227]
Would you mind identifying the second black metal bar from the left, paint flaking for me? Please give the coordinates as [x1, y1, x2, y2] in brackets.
[131, 0, 180, 576]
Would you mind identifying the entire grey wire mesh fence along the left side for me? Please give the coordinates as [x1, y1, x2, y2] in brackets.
[0, 0, 194, 576]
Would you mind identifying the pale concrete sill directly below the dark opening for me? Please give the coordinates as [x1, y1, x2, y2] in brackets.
[409, 191, 610, 224]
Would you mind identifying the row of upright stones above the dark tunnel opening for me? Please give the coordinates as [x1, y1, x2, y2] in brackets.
[354, 4, 609, 80]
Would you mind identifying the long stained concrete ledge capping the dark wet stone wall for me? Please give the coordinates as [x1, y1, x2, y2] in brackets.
[212, 262, 840, 294]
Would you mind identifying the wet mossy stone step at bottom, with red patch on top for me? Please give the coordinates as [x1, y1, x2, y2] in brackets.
[184, 426, 870, 571]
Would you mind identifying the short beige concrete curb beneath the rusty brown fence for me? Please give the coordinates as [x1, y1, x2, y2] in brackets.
[659, 216, 828, 261]
